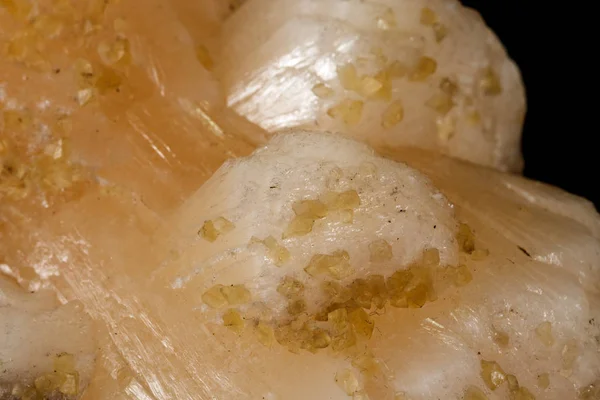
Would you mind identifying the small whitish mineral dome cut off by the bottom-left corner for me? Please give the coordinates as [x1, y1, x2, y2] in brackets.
[0, 276, 95, 399]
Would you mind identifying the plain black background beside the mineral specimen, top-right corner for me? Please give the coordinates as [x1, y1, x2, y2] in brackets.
[462, 0, 600, 209]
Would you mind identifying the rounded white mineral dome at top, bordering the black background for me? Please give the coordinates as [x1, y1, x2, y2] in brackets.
[214, 0, 525, 171]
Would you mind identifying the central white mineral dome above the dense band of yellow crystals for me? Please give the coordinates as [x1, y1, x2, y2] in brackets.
[157, 132, 458, 313]
